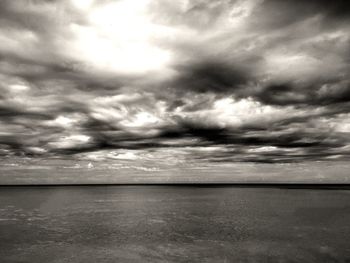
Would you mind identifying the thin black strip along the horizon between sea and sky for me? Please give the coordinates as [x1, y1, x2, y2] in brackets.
[0, 182, 350, 190]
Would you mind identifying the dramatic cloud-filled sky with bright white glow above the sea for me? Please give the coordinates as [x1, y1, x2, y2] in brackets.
[0, 0, 350, 183]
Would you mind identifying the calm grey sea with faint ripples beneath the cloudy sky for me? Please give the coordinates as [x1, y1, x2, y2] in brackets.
[0, 185, 350, 263]
